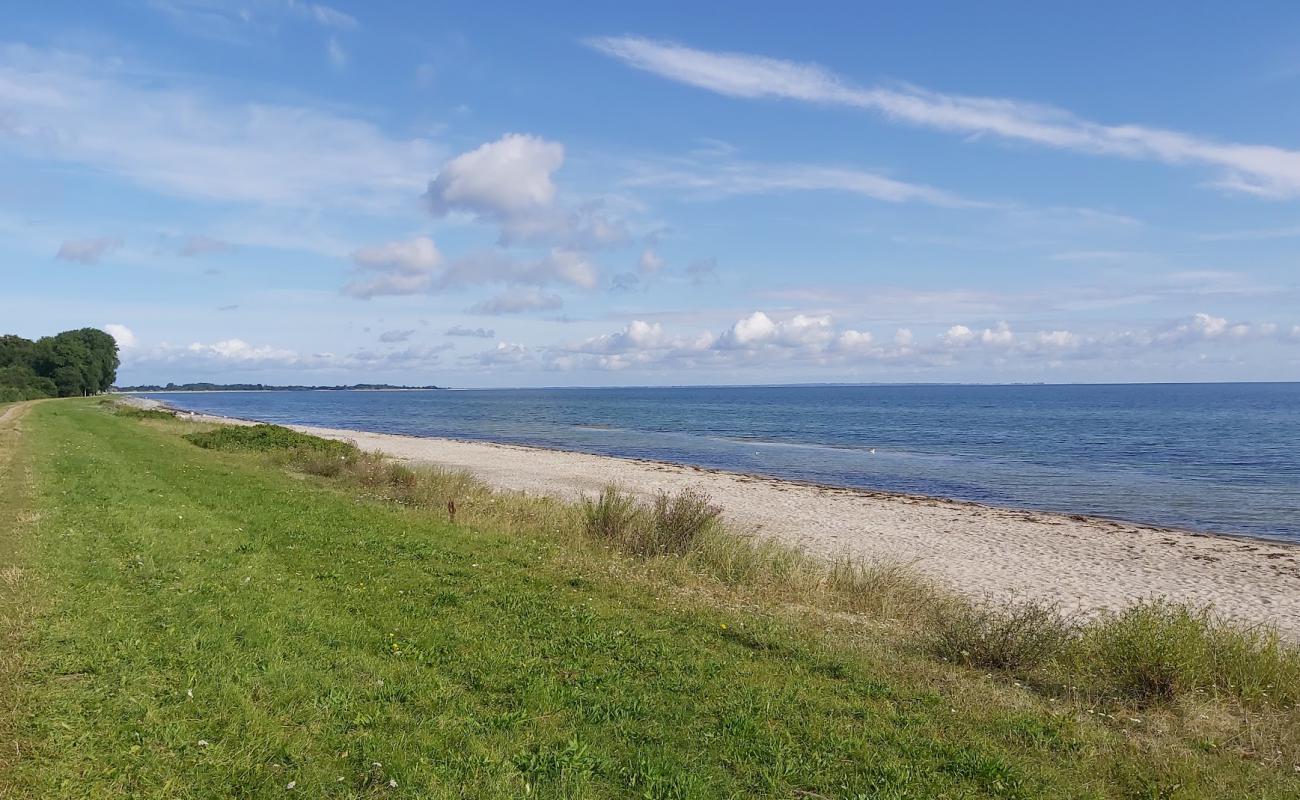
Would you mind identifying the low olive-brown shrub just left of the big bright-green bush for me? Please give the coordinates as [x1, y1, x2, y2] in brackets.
[930, 600, 1078, 674]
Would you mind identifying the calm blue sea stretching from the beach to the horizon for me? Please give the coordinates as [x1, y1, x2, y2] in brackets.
[144, 384, 1300, 541]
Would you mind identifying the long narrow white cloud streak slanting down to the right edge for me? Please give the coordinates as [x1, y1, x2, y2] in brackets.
[589, 36, 1300, 198]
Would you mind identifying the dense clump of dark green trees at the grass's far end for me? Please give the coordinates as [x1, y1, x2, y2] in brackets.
[0, 328, 120, 403]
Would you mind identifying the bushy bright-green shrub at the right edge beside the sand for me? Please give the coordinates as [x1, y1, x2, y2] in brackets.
[1071, 600, 1300, 706]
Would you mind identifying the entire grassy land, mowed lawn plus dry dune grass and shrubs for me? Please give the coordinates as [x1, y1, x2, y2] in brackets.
[0, 401, 1300, 797]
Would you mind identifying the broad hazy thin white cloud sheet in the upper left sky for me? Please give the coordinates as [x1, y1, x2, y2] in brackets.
[0, 44, 441, 211]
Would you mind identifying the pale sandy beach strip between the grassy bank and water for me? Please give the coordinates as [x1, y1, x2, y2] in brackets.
[139, 398, 1300, 640]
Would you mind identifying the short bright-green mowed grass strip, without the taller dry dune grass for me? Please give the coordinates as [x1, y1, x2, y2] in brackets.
[0, 401, 1300, 797]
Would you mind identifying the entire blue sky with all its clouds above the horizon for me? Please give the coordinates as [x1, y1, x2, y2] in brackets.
[0, 0, 1300, 386]
